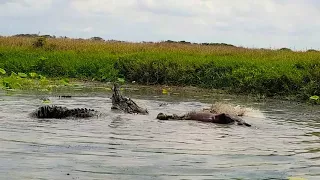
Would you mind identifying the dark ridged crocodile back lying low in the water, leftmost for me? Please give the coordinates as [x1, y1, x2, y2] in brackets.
[31, 105, 98, 119]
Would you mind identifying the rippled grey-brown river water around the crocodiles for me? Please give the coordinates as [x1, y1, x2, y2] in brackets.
[0, 86, 320, 180]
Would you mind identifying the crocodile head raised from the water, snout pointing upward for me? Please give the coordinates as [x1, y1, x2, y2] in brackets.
[111, 84, 148, 114]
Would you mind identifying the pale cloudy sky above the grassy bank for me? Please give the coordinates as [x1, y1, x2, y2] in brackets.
[0, 0, 320, 50]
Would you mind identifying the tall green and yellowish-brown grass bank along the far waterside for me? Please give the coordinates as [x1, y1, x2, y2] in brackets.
[0, 37, 320, 103]
